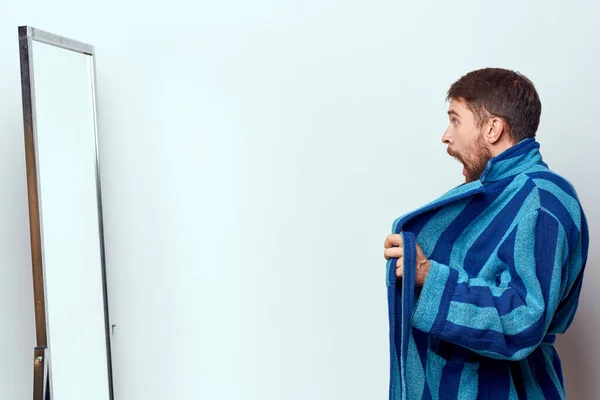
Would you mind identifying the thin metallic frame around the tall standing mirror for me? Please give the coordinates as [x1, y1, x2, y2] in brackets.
[18, 26, 114, 400]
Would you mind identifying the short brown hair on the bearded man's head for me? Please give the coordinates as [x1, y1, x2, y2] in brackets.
[446, 68, 542, 144]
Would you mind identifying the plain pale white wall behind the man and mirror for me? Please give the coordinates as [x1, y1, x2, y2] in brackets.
[0, 0, 600, 400]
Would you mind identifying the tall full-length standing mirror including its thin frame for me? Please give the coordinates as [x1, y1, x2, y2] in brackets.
[19, 27, 113, 400]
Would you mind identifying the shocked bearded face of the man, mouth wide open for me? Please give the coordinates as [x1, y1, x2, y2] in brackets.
[442, 99, 492, 182]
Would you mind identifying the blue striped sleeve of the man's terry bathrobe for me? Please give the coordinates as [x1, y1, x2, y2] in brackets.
[412, 208, 569, 361]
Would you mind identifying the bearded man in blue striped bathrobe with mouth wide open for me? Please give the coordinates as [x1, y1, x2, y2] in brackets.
[384, 69, 588, 400]
